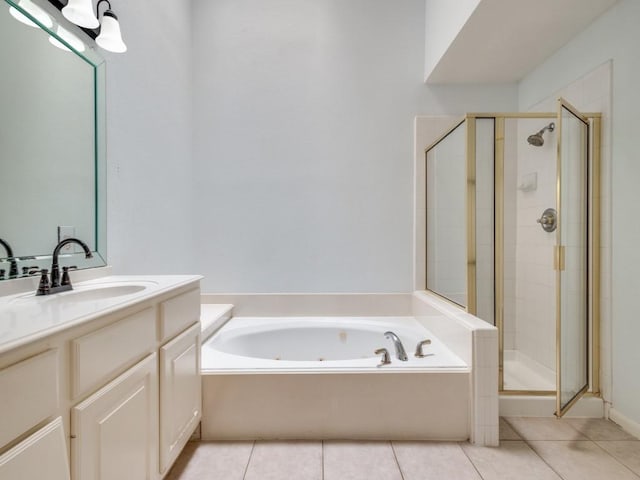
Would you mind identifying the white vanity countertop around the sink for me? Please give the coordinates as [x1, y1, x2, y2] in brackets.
[0, 275, 202, 354]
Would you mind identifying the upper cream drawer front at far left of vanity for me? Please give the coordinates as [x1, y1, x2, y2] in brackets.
[0, 349, 59, 447]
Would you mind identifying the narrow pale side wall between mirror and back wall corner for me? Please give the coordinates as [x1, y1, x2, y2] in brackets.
[101, 0, 197, 274]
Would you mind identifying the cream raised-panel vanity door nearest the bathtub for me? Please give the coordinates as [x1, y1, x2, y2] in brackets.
[160, 323, 202, 473]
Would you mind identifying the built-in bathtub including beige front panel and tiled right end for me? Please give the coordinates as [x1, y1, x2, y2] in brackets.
[201, 292, 498, 445]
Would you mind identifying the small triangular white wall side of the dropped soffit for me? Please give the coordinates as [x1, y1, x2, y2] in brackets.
[424, 0, 480, 79]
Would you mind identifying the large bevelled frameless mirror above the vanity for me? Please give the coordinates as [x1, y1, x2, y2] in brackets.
[0, 0, 106, 279]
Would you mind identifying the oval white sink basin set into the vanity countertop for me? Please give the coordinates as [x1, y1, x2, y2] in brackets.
[12, 282, 155, 304]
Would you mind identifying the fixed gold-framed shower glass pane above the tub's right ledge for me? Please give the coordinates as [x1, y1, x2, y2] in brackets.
[426, 122, 467, 306]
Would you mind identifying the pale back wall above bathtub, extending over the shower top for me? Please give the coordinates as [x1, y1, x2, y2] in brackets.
[193, 0, 515, 292]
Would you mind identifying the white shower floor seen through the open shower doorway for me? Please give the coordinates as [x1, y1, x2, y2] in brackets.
[504, 350, 556, 390]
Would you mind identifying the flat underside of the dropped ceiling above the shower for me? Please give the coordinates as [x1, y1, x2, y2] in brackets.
[426, 0, 617, 83]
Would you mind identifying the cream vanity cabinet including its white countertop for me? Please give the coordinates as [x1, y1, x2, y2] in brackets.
[0, 275, 201, 480]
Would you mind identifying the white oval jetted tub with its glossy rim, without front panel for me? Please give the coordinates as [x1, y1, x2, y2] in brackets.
[202, 317, 469, 374]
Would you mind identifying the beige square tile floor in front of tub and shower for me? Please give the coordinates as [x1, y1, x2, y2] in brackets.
[167, 417, 640, 480]
